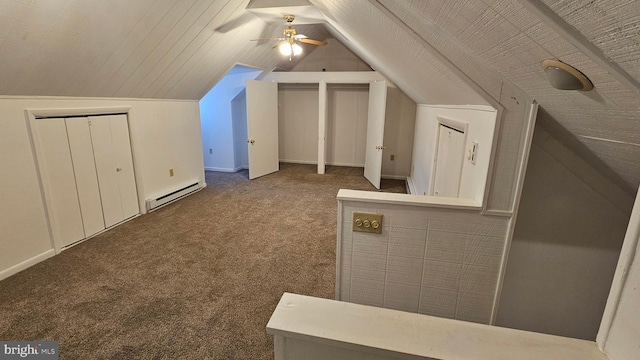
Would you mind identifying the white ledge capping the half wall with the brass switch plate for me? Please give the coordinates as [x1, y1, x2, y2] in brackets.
[337, 189, 482, 210]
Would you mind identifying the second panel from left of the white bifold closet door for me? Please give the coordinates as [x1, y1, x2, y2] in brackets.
[65, 118, 105, 237]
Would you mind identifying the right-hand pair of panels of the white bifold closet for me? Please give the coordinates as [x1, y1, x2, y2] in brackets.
[89, 115, 139, 227]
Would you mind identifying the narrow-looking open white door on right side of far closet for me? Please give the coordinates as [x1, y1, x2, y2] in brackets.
[364, 81, 387, 189]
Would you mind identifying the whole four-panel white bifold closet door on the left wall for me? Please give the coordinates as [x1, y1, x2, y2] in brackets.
[37, 115, 139, 248]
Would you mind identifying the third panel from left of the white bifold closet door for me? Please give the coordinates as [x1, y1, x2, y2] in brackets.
[89, 116, 124, 227]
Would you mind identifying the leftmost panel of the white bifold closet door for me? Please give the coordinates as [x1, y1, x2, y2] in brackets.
[37, 119, 85, 247]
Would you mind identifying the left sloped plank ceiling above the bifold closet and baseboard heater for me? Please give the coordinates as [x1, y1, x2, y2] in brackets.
[0, 0, 327, 99]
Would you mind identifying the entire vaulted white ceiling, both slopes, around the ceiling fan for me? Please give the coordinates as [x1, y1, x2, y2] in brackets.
[0, 0, 640, 192]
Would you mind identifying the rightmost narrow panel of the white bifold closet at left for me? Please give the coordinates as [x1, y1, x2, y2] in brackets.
[109, 115, 140, 219]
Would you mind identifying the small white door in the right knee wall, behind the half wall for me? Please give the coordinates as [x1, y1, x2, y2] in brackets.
[432, 124, 465, 197]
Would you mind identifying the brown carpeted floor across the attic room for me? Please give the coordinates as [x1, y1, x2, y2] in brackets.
[0, 164, 405, 359]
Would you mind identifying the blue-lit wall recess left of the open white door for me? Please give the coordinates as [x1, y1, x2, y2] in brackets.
[200, 65, 262, 171]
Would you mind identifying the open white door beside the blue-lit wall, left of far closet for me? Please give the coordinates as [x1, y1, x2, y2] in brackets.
[247, 80, 280, 179]
